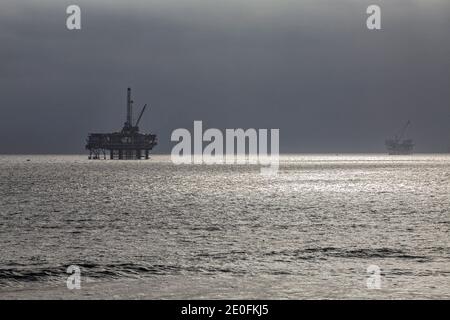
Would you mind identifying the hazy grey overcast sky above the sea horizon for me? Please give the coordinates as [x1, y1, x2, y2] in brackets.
[0, 0, 450, 153]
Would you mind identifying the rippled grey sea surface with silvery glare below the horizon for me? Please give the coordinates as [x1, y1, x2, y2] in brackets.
[0, 154, 450, 299]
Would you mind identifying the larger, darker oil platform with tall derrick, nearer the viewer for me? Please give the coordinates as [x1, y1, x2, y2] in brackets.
[86, 88, 157, 160]
